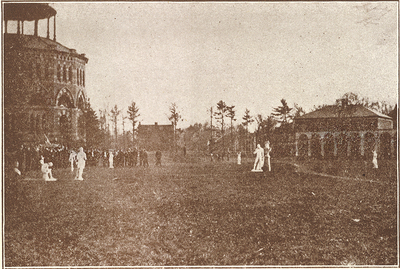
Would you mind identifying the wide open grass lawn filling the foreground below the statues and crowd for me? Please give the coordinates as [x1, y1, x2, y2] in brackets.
[4, 154, 397, 266]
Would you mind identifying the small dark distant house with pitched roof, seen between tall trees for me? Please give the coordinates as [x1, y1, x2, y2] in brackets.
[138, 122, 174, 151]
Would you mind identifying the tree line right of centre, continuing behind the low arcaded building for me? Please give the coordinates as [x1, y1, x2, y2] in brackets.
[181, 93, 394, 155]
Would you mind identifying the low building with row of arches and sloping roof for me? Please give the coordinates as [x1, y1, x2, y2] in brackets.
[294, 103, 397, 158]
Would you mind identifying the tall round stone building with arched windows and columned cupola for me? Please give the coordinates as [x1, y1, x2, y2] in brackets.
[3, 3, 88, 148]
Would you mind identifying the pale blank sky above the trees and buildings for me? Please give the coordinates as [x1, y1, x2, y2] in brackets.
[51, 2, 398, 128]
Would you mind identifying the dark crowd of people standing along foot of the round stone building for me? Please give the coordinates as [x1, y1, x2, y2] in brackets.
[14, 145, 156, 172]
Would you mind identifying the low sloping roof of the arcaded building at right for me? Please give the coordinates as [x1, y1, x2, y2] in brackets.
[296, 105, 391, 119]
